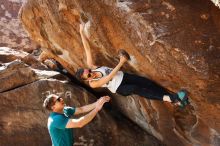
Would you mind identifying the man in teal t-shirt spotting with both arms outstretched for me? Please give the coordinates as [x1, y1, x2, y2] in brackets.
[43, 94, 110, 146]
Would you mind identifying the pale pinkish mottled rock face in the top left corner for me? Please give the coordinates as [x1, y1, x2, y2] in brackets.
[0, 0, 34, 51]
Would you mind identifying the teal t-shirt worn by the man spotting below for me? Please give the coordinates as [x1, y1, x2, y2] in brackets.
[47, 107, 75, 146]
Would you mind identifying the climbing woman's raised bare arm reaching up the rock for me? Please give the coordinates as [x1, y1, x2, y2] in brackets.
[80, 24, 97, 69]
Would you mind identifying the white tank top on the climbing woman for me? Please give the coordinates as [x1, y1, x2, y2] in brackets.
[92, 66, 124, 93]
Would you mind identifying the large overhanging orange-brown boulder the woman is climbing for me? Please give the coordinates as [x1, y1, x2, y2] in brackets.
[20, 0, 220, 145]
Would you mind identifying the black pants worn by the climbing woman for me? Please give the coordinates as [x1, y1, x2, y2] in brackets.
[116, 73, 170, 101]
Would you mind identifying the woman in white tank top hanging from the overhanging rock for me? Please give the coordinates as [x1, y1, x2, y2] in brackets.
[76, 23, 189, 107]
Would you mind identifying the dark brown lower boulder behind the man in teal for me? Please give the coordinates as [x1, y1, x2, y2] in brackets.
[0, 48, 161, 146]
